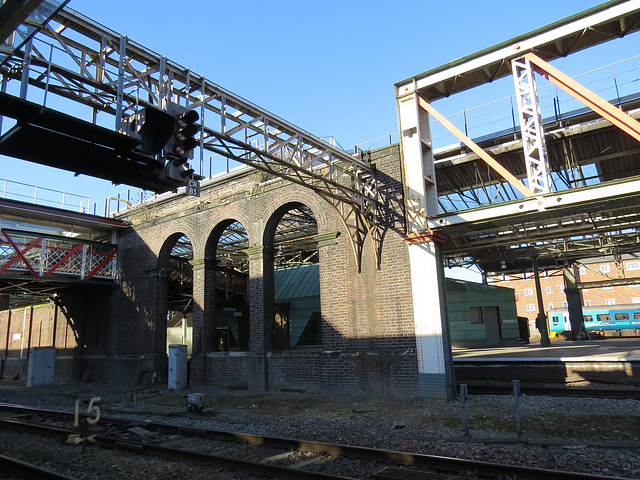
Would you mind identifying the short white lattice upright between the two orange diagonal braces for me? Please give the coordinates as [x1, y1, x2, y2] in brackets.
[511, 57, 552, 195]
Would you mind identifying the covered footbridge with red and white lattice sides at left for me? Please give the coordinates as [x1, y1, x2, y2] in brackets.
[0, 199, 127, 295]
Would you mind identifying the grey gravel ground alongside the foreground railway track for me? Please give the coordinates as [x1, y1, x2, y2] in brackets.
[0, 381, 640, 479]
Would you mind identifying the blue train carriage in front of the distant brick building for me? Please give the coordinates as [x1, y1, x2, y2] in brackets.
[549, 304, 640, 337]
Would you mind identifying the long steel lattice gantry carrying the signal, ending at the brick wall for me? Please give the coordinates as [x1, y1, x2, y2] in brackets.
[0, 8, 377, 264]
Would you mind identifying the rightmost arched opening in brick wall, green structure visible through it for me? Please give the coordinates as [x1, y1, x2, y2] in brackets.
[271, 203, 322, 351]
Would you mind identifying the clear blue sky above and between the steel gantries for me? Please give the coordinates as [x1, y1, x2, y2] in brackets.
[0, 0, 640, 214]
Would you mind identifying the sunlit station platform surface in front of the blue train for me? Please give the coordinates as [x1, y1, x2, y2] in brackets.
[452, 338, 640, 361]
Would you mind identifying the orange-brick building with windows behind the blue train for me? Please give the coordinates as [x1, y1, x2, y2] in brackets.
[488, 254, 640, 337]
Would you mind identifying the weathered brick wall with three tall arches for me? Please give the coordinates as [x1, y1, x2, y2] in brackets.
[107, 145, 417, 394]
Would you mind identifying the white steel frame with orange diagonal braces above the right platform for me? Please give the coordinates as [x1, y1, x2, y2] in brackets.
[396, 0, 640, 272]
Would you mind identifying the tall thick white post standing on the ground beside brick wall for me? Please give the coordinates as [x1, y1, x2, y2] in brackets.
[397, 91, 455, 400]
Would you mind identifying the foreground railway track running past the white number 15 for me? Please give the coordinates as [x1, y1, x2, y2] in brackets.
[0, 404, 632, 480]
